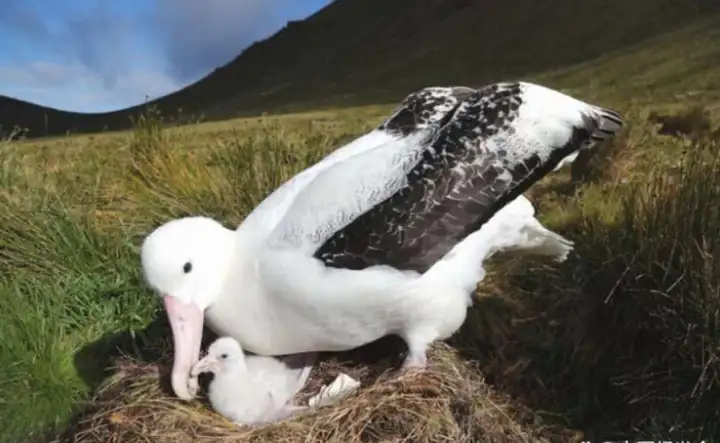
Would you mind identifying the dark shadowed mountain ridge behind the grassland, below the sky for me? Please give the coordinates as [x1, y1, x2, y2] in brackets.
[0, 0, 720, 137]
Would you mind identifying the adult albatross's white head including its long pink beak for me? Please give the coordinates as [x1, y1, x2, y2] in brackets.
[140, 217, 234, 400]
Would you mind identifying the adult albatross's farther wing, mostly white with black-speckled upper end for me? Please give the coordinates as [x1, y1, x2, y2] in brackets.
[262, 86, 476, 253]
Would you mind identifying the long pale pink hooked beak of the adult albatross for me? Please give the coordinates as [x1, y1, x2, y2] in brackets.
[163, 295, 203, 400]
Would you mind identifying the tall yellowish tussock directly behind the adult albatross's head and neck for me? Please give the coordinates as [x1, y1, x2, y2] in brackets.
[123, 109, 337, 224]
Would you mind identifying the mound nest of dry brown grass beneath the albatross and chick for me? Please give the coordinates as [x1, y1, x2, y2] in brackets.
[57, 338, 572, 443]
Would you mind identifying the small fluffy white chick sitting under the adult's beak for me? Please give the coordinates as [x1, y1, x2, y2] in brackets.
[190, 337, 317, 426]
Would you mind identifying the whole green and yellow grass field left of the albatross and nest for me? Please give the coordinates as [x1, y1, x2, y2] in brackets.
[0, 108, 366, 442]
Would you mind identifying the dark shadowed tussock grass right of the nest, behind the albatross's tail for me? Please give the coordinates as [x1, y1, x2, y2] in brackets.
[458, 116, 720, 441]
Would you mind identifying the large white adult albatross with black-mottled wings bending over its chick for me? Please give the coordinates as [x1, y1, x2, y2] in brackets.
[141, 82, 622, 399]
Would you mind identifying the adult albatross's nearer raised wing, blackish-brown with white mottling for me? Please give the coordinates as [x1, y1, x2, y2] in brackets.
[314, 83, 622, 272]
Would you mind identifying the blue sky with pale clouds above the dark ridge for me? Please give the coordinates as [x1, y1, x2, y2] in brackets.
[0, 0, 328, 112]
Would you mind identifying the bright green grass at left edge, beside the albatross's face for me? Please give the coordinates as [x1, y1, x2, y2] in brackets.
[0, 155, 155, 441]
